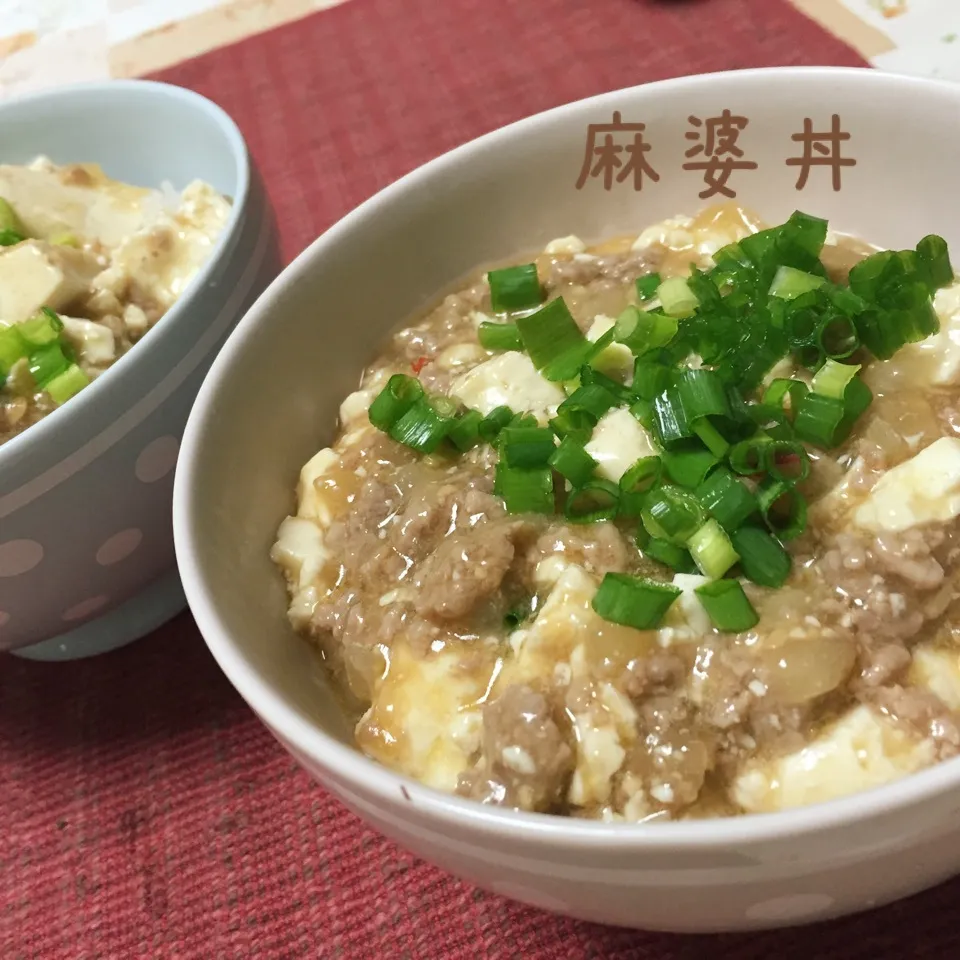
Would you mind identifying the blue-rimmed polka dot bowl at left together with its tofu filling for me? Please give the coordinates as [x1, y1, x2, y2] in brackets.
[0, 82, 278, 658]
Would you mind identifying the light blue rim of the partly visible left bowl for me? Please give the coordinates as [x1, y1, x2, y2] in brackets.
[0, 79, 252, 476]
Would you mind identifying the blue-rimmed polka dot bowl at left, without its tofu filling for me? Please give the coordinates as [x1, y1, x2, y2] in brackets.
[0, 81, 279, 659]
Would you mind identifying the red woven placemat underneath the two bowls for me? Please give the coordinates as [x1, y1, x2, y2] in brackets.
[0, 0, 948, 960]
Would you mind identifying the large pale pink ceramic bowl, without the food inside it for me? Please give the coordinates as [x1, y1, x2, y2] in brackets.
[174, 68, 960, 931]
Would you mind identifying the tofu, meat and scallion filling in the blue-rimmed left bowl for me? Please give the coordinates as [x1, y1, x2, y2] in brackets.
[0, 157, 232, 446]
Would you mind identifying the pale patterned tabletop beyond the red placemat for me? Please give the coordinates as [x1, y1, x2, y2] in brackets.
[0, 0, 960, 97]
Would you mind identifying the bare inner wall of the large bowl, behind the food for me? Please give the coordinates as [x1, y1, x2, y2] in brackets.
[175, 69, 960, 776]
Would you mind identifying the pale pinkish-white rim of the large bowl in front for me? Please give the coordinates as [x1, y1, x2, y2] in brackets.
[173, 67, 960, 851]
